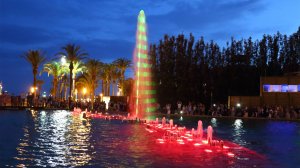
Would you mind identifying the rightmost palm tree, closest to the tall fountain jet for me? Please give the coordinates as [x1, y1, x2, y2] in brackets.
[113, 58, 131, 96]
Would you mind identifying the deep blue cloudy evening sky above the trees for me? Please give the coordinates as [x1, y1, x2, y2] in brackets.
[0, 0, 300, 94]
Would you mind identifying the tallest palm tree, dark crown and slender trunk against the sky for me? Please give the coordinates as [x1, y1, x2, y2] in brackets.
[59, 44, 88, 107]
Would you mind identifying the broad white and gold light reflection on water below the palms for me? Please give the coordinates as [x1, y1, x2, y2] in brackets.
[15, 111, 91, 167]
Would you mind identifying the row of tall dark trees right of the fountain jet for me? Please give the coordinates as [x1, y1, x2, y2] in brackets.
[149, 27, 300, 105]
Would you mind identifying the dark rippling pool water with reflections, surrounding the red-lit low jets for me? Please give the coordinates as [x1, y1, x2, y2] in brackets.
[0, 111, 300, 167]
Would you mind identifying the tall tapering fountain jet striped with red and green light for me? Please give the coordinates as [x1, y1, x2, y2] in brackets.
[130, 10, 156, 118]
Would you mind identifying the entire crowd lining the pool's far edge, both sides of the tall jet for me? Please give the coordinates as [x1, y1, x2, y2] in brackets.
[7, 96, 300, 120]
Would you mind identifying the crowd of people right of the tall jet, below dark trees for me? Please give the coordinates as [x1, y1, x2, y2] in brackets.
[160, 101, 300, 120]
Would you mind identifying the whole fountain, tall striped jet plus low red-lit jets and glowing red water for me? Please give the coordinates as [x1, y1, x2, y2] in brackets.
[67, 10, 268, 167]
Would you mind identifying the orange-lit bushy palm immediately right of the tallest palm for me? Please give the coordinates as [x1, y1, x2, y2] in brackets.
[77, 59, 103, 108]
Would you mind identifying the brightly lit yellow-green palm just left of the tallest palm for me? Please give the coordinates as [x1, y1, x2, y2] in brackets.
[41, 61, 68, 98]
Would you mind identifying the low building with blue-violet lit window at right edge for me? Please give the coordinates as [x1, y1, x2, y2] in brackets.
[228, 74, 300, 107]
